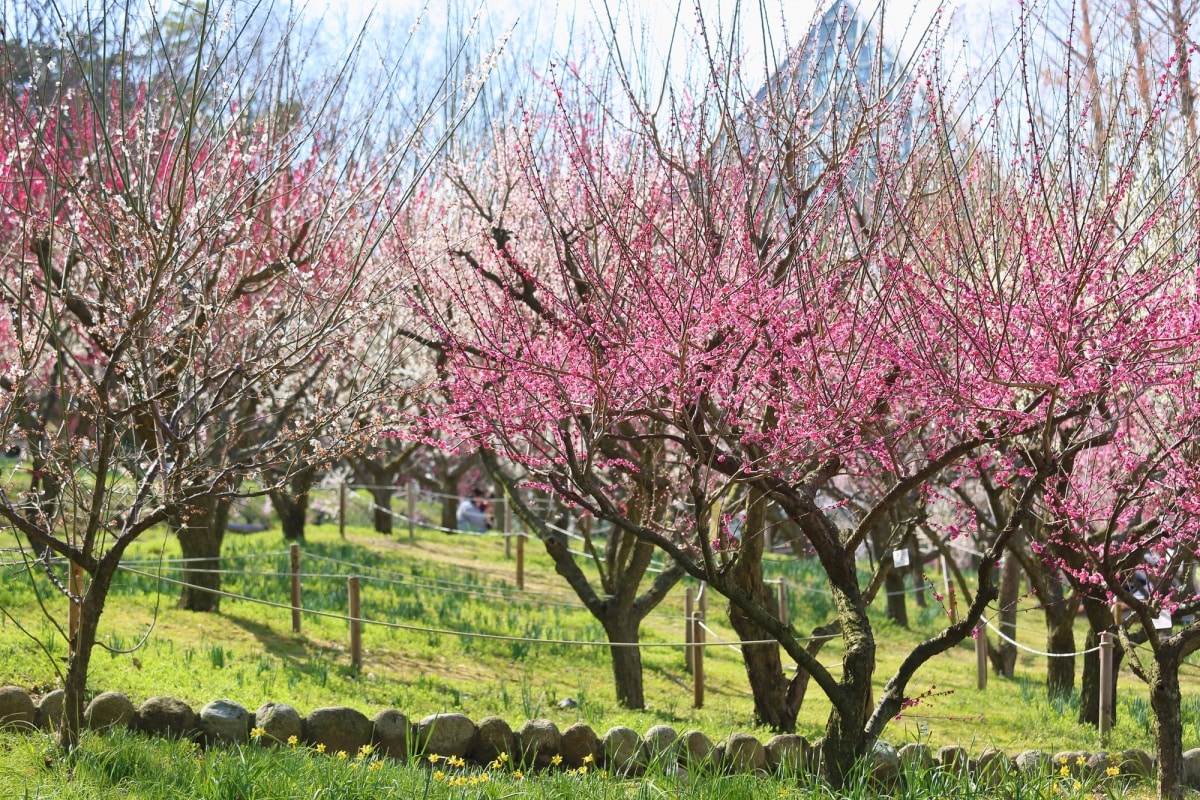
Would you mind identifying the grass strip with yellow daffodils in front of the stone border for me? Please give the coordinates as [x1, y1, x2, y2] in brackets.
[0, 732, 1146, 800]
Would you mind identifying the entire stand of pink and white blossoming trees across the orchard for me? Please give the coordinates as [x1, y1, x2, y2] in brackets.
[0, 0, 1200, 798]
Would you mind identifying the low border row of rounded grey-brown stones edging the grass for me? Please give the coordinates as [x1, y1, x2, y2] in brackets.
[0, 686, 1171, 788]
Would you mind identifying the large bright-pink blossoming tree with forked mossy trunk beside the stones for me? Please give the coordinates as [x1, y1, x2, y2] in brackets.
[415, 1, 1195, 783]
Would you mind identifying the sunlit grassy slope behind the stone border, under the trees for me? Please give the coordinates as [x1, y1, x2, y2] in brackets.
[0, 513, 1200, 752]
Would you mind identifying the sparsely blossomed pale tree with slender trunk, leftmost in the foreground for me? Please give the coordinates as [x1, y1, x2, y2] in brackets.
[0, 6, 477, 747]
